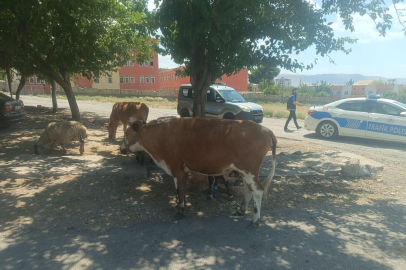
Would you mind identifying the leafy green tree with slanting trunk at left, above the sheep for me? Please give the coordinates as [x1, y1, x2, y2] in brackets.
[0, 0, 154, 120]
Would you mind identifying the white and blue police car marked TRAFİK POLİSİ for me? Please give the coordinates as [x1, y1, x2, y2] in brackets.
[304, 95, 406, 142]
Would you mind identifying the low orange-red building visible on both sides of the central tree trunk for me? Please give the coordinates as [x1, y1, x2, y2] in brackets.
[159, 69, 248, 92]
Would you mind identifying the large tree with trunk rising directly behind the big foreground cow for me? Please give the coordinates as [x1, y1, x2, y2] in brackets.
[156, 0, 402, 116]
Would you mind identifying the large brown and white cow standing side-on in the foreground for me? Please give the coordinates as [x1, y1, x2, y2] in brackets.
[121, 118, 277, 224]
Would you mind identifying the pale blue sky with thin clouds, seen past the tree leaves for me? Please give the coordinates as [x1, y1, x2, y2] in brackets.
[148, 0, 406, 79]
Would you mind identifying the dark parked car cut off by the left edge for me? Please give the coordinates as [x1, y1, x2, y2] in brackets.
[0, 93, 25, 127]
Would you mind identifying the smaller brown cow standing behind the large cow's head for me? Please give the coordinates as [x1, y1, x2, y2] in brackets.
[105, 102, 149, 140]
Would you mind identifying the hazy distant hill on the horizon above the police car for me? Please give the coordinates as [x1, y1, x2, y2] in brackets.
[276, 74, 406, 86]
